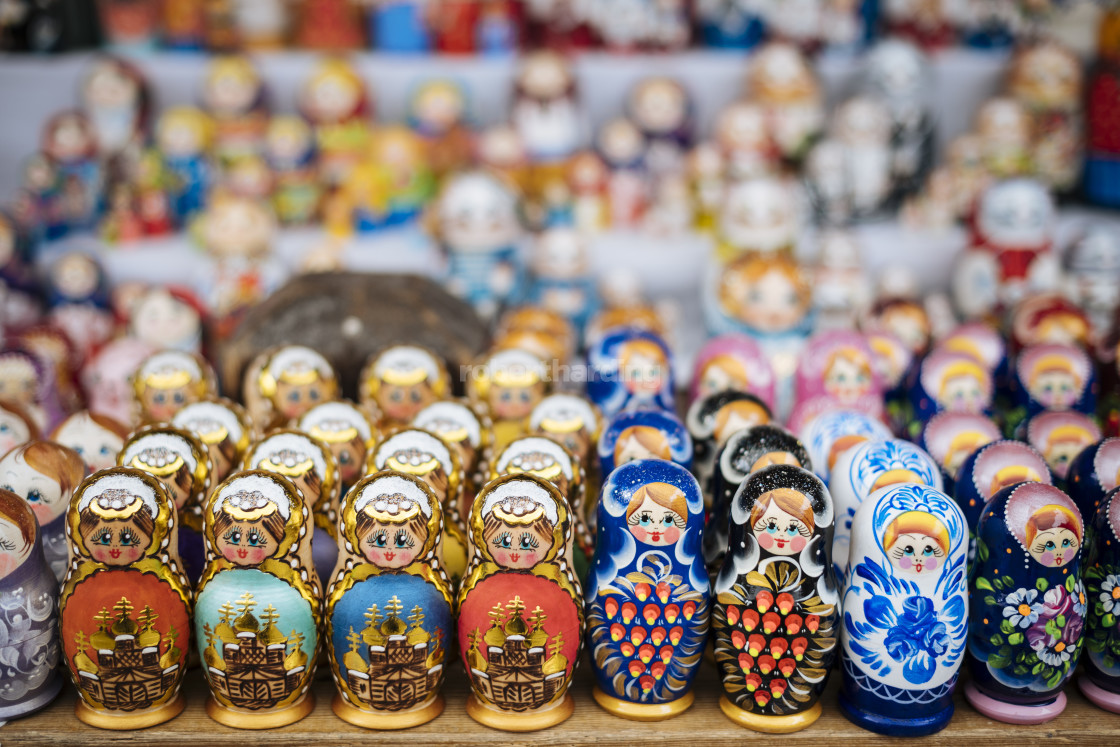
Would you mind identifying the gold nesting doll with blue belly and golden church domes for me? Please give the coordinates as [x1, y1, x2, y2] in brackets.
[325, 470, 455, 729]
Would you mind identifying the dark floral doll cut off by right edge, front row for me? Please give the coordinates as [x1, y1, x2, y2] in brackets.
[1077, 488, 1120, 713]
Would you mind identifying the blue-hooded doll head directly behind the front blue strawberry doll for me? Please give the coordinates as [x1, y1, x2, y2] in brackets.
[597, 410, 692, 477]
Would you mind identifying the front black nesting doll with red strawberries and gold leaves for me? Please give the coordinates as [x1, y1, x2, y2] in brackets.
[712, 465, 840, 734]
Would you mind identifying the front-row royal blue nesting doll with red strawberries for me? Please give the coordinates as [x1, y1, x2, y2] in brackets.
[585, 460, 711, 721]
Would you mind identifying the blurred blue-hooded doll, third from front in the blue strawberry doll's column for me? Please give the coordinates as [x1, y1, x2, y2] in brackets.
[587, 327, 675, 418]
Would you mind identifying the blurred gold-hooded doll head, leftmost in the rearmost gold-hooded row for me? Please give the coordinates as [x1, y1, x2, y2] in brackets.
[132, 351, 217, 422]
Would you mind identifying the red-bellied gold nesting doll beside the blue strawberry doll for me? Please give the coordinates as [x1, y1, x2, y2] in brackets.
[458, 475, 584, 731]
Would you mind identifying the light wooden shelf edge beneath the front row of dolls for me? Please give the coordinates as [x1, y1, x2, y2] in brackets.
[0, 660, 1120, 747]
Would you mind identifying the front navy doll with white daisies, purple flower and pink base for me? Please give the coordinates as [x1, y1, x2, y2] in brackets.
[964, 483, 1086, 723]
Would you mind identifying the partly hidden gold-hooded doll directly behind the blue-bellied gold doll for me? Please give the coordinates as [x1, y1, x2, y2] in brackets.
[365, 428, 470, 580]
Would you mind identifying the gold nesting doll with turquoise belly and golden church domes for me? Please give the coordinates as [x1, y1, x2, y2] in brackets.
[194, 470, 323, 729]
